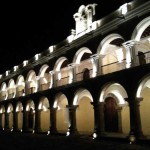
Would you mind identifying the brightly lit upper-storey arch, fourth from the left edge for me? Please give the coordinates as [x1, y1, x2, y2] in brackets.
[25, 70, 38, 94]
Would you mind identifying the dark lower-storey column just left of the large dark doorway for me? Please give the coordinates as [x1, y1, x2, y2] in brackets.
[91, 102, 105, 136]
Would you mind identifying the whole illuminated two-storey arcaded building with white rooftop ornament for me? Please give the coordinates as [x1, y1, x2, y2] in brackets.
[0, 0, 150, 142]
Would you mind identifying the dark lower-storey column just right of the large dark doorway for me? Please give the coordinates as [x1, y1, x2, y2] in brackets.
[126, 98, 143, 137]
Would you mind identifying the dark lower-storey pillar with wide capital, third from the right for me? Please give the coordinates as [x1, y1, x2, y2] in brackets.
[66, 105, 78, 135]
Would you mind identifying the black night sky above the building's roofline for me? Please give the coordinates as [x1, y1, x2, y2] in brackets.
[0, 0, 131, 74]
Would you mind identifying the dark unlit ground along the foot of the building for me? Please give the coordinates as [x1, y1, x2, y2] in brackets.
[0, 132, 150, 150]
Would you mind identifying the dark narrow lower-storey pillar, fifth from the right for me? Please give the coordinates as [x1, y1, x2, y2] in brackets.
[34, 109, 42, 133]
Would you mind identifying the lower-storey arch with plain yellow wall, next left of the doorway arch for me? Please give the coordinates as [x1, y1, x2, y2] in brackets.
[73, 89, 94, 134]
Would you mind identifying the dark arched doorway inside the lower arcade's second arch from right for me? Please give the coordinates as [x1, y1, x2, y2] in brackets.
[104, 97, 118, 132]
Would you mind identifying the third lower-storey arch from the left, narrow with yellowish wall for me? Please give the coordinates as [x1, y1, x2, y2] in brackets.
[15, 101, 23, 131]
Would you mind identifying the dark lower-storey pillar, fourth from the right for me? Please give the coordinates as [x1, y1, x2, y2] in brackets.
[50, 108, 57, 134]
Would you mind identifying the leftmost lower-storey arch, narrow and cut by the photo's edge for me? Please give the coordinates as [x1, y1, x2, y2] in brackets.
[0, 105, 5, 130]
